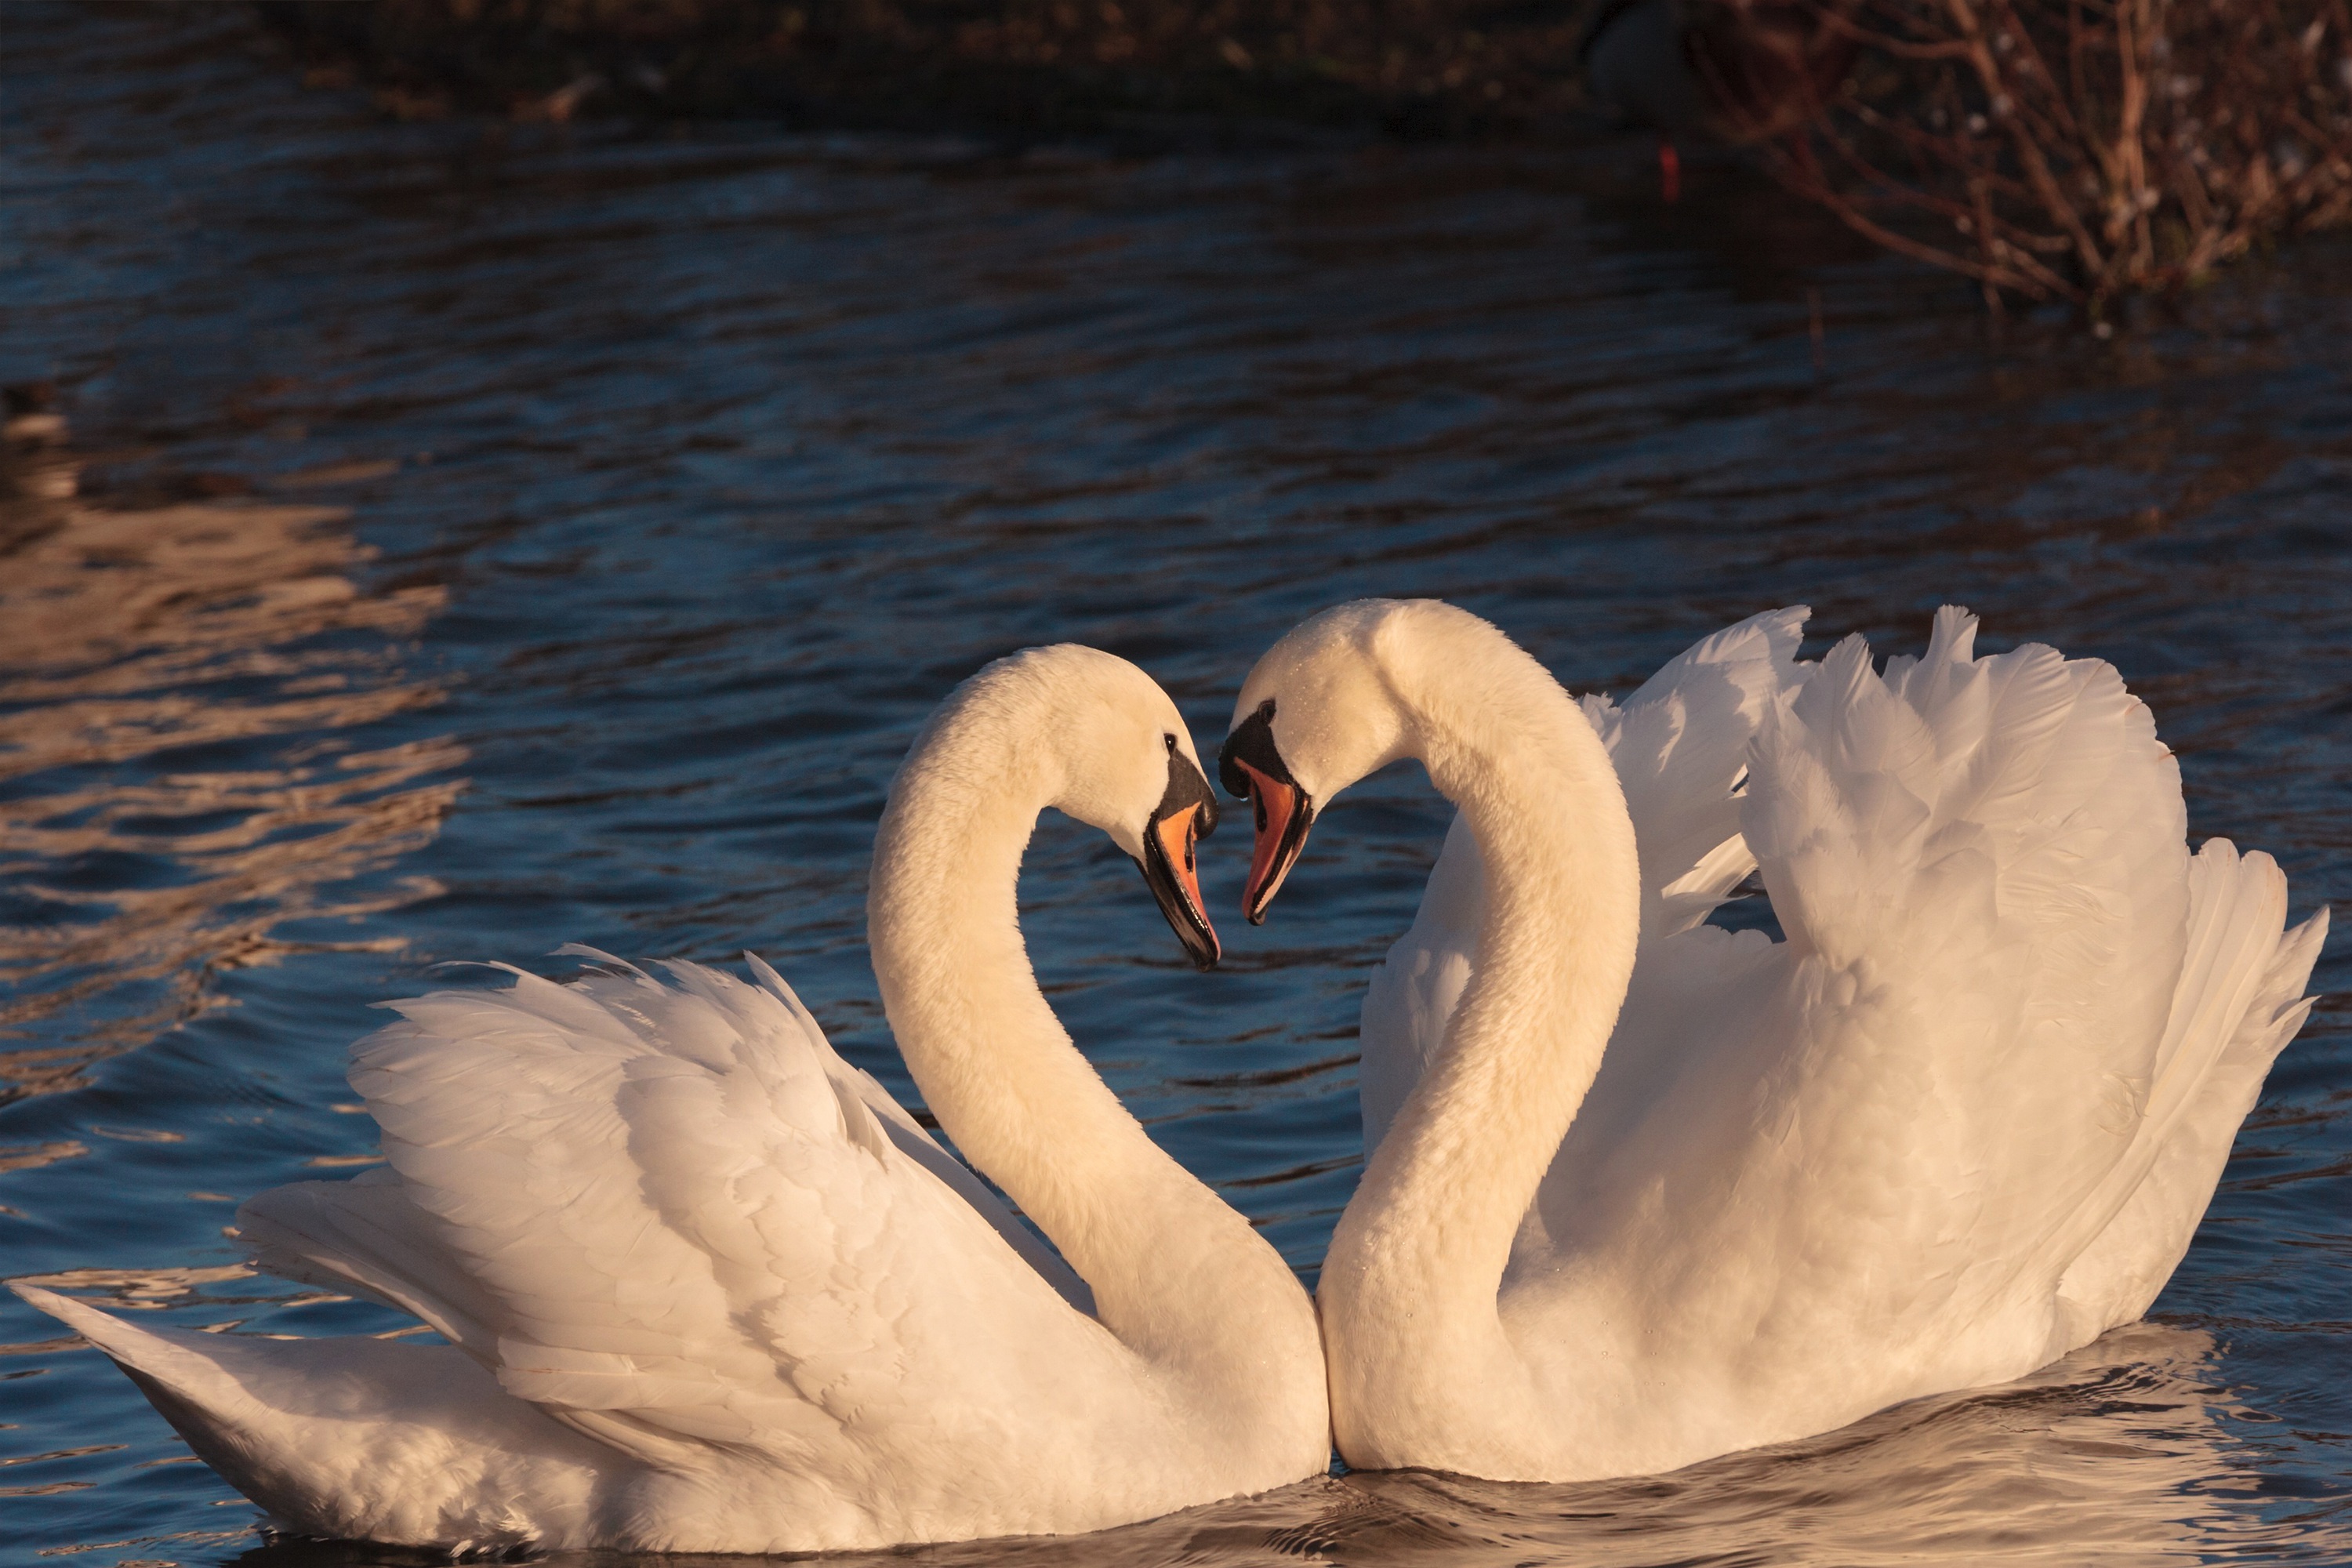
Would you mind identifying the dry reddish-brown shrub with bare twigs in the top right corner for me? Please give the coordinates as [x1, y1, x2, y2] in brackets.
[1740, 0, 2352, 313]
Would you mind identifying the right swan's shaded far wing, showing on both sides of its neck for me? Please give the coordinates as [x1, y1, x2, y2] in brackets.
[1357, 607, 1811, 1156]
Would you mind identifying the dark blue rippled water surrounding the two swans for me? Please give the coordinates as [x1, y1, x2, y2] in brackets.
[0, 5, 2352, 1568]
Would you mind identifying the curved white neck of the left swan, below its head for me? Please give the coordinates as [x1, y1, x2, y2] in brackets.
[868, 682, 1319, 1399]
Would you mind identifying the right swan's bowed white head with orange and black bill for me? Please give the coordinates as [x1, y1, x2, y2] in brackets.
[1216, 600, 1439, 926]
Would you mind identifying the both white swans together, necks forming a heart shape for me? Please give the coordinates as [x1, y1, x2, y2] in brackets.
[19, 602, 2324, 1552]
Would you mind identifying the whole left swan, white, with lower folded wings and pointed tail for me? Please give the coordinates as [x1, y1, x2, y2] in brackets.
[19, 647, 1329, 1552]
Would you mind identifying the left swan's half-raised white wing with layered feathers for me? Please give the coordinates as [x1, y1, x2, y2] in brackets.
[240, 964, 1131, 1469]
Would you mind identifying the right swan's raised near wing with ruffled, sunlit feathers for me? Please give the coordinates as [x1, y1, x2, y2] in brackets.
[1743, 607, 2187, 1300]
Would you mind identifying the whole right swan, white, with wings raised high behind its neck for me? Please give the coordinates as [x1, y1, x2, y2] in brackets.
[1223, 602, 2326, 1481]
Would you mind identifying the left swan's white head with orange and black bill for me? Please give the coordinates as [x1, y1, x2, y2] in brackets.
[931, 642, 1221, 968]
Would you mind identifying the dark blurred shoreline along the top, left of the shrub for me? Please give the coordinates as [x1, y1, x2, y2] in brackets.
[259, 0, 1604, 151]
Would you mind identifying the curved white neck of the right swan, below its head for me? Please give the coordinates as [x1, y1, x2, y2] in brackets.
[1324, 619, 1642, 1330]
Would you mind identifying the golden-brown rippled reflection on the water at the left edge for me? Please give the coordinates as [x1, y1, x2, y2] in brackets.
[0, 452, 463, 1102]
